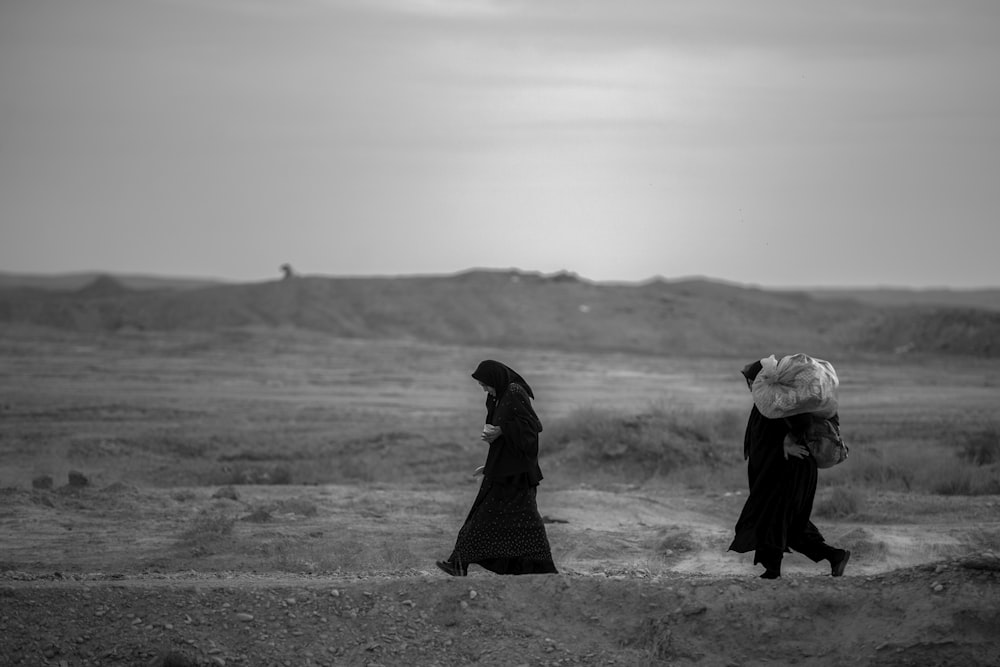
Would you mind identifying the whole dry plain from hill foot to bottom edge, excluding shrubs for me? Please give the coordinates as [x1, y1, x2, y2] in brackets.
[0, 330, 1000, 665]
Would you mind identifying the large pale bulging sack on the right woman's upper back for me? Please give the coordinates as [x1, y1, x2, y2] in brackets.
[750, 354, 840, 419]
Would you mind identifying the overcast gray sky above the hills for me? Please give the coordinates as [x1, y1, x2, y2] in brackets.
[0, 0, 1000, 287]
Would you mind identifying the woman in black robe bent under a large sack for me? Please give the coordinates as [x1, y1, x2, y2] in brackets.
[729, 361, 851, 579]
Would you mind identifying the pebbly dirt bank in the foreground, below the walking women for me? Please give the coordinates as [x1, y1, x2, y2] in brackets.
[0, 561, 1000, 666]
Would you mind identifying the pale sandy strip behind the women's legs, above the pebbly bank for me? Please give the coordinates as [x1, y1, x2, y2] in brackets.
[0, 482, 1000, 576]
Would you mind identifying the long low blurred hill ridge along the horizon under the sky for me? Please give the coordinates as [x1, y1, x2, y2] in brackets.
[0, 270, 1000, 357]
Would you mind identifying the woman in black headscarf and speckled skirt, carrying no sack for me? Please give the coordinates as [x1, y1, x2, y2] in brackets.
[437, 359, 556, 577]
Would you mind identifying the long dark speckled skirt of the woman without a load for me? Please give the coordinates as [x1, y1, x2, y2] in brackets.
[448, 479, 557, 574]
